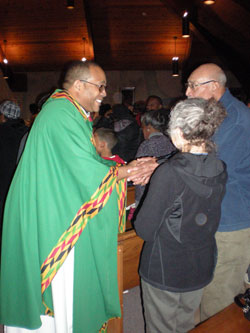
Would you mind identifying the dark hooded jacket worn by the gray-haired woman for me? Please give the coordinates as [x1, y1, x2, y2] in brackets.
[135, 153, 227, 292]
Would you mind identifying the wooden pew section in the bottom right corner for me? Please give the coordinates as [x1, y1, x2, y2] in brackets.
[189, 303, 250, 333]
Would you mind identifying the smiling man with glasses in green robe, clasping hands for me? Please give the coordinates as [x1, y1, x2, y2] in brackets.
[0, 61, 157, 333]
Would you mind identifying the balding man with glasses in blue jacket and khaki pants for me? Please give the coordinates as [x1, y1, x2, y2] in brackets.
[186, 64, 250, 320]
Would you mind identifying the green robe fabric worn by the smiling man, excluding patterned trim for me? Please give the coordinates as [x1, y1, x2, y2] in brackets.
[0, 91, 124, 333]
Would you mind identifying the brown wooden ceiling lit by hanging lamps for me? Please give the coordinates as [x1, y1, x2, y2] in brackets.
[0, 0, 250, 88]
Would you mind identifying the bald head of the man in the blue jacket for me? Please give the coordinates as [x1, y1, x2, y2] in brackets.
[186, 64, 227, 100]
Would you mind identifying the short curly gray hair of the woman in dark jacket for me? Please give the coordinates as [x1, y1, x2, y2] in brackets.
[168, 98, 227, 151]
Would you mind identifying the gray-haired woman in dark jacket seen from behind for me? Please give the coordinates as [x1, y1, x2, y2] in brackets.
[135, 98, 227, 333]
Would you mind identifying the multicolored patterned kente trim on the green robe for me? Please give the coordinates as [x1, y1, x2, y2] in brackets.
[40, 91, 126, 316]
